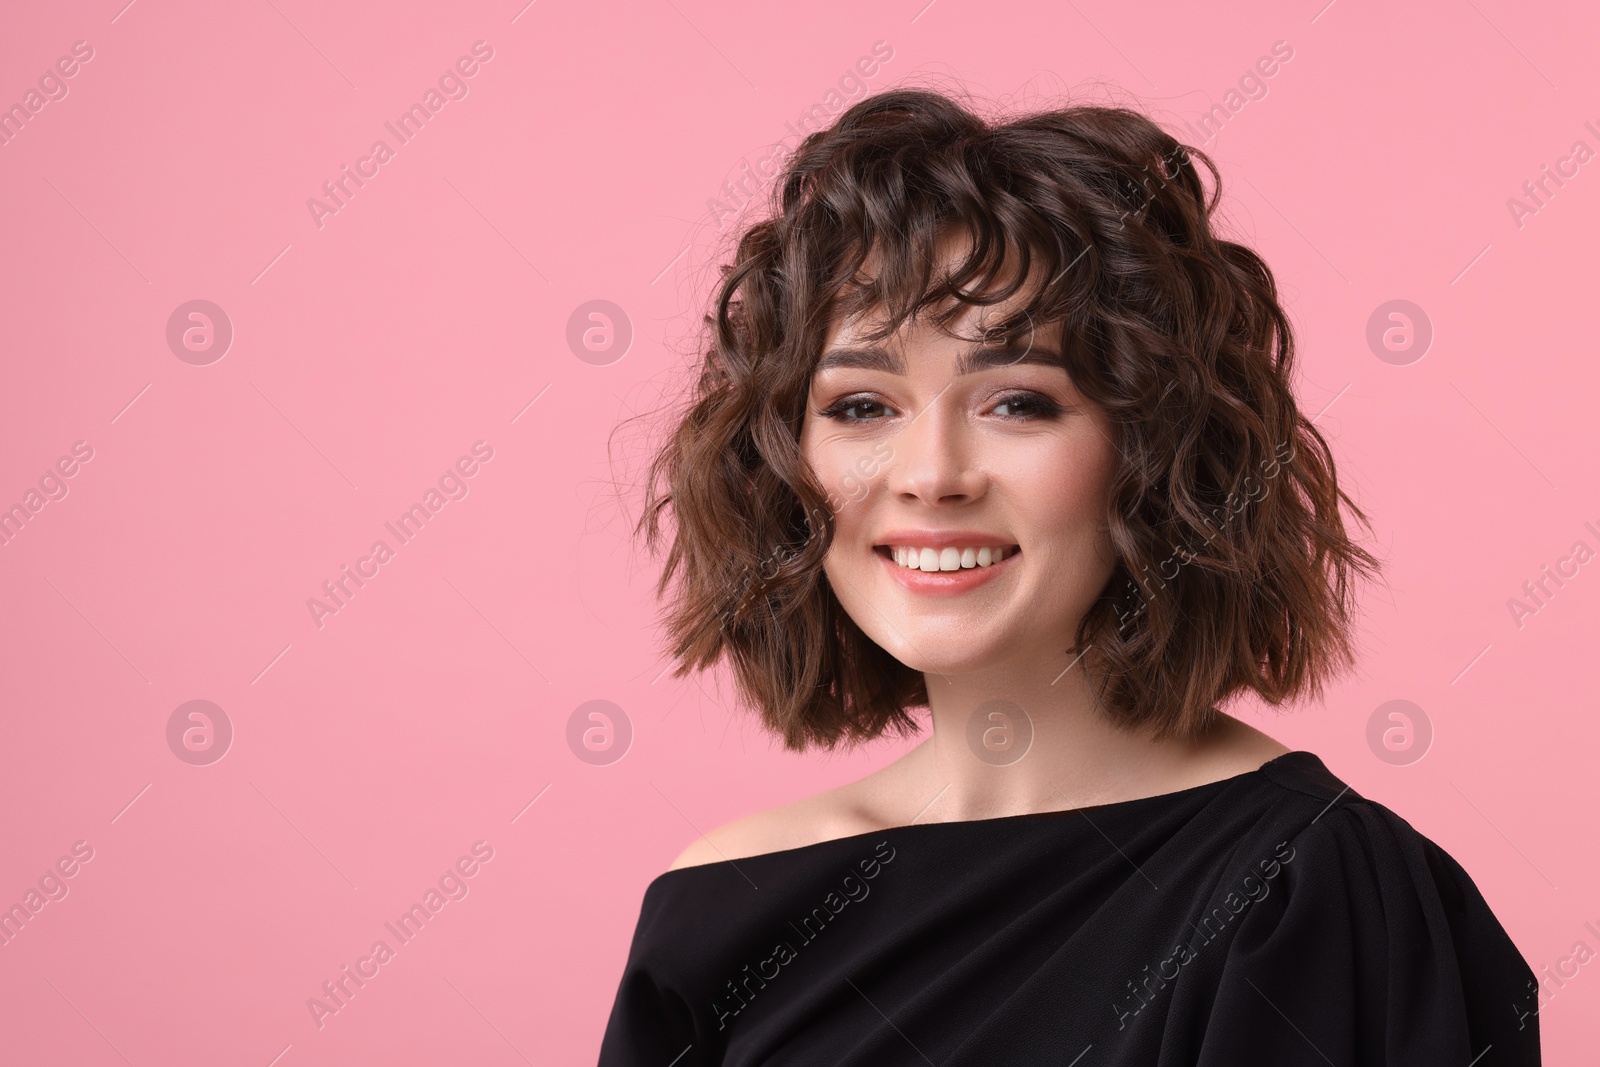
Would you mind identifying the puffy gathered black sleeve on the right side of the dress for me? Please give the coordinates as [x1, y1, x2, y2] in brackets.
[1197, 800, 1539, 1067]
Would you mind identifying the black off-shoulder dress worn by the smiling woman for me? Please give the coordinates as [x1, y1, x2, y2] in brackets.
[600, 752, 1539, 1067]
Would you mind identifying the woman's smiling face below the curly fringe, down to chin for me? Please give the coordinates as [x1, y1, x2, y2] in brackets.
[800, 294, 1115, 677]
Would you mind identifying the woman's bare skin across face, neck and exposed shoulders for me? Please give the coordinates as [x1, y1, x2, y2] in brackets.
[672, 244, 1288, 869]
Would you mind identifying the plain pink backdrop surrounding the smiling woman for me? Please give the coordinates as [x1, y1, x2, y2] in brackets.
[0, 0, 1600, 1067]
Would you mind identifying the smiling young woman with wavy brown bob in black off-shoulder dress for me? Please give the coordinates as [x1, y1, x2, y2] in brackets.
[600, 90, 1539, 1067]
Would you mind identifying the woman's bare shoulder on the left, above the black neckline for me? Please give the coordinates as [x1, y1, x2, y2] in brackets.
[667, 765, 915, 870]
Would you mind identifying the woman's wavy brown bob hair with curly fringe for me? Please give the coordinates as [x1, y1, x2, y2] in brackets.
[637, 88, 1379, 749]
